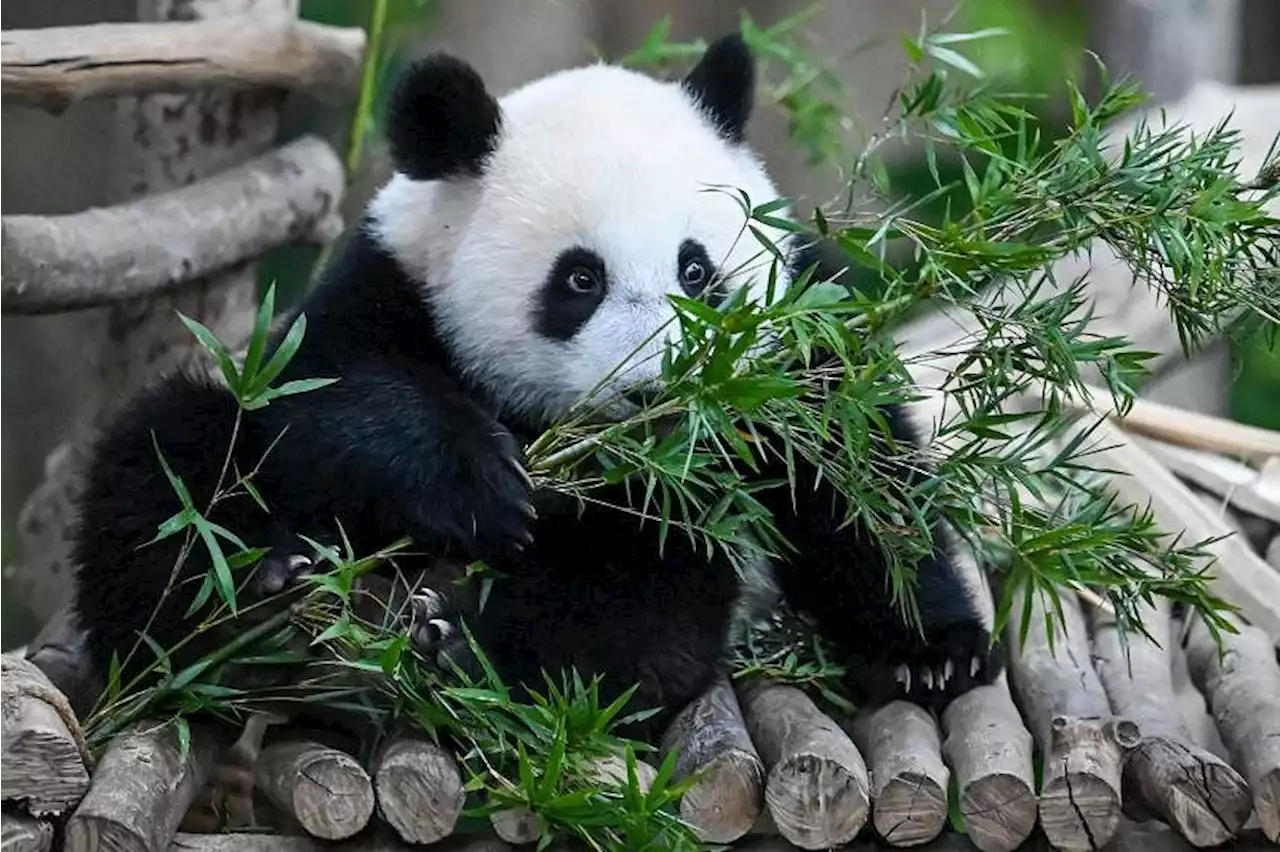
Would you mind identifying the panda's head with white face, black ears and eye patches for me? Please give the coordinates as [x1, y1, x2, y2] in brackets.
[370, 36, 787, 420]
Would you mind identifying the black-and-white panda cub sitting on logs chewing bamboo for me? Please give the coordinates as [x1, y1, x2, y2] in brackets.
[67, 36, 998, 736]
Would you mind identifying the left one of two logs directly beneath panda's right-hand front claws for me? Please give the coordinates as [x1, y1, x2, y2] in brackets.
[854, 701, 951, 846]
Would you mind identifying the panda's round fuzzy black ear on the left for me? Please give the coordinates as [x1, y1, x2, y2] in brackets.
[385, 54, 502, 180]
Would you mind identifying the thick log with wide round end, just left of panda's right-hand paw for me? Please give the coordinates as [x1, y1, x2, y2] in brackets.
[740, 683, 869, 849]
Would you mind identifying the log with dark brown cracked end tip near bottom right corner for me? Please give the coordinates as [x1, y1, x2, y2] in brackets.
[1091, 599, 1253, 847]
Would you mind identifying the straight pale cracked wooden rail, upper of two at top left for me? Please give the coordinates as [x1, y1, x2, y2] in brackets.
[0, 14, 365, 114]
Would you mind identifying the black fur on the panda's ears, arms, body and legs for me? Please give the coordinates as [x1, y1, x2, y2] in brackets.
[64, 41, 996, 736]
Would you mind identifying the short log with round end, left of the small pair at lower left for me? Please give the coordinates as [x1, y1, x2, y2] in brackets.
[255, 739, 374, 840]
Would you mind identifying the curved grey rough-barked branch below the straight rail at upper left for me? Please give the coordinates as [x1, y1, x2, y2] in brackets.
[0, 137, 344, 313]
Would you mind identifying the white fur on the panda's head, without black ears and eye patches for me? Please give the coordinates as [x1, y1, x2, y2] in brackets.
[371, 65, 788, 418]
